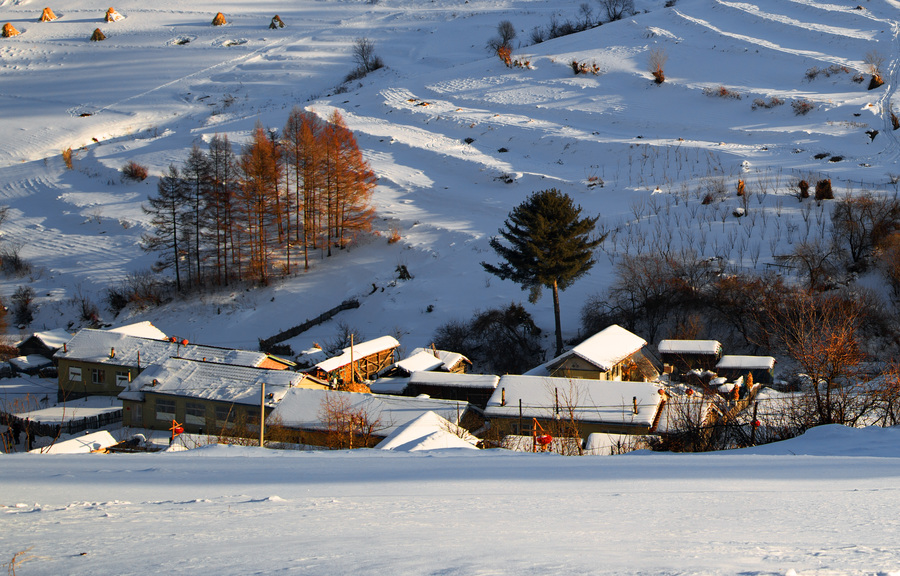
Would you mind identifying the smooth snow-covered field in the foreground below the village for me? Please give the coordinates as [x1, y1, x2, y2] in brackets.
[0, 426, 900, 575]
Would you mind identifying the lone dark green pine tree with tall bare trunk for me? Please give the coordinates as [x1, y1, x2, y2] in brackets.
[481, 188, 603, 356]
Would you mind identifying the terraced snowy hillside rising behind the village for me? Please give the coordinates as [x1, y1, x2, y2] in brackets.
[0, 0, 900, 350]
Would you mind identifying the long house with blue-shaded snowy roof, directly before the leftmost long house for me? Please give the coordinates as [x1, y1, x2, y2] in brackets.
[119, 358, 328, 435]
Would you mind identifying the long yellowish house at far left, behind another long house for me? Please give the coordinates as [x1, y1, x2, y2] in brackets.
[53, 328, 292, 401]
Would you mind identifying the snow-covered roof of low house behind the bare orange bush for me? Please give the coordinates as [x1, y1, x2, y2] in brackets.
[269, 388, 469, 436]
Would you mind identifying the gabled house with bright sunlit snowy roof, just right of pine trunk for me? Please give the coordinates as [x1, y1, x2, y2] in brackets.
[525, 324, 659, 382]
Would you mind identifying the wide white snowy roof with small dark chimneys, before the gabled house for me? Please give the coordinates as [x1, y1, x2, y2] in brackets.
[485, 375, 662, 426]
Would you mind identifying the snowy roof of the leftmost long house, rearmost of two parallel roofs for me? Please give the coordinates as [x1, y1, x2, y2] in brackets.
[53, 328, 267, 367]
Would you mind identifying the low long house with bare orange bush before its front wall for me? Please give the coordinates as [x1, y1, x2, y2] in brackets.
[266, 388, 469, 448]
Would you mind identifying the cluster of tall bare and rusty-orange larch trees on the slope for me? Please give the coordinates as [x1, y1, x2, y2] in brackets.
[143, 108, 376, 291]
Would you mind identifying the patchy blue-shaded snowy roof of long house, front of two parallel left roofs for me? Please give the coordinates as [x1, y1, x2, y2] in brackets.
[119, 358, 318, 406]
